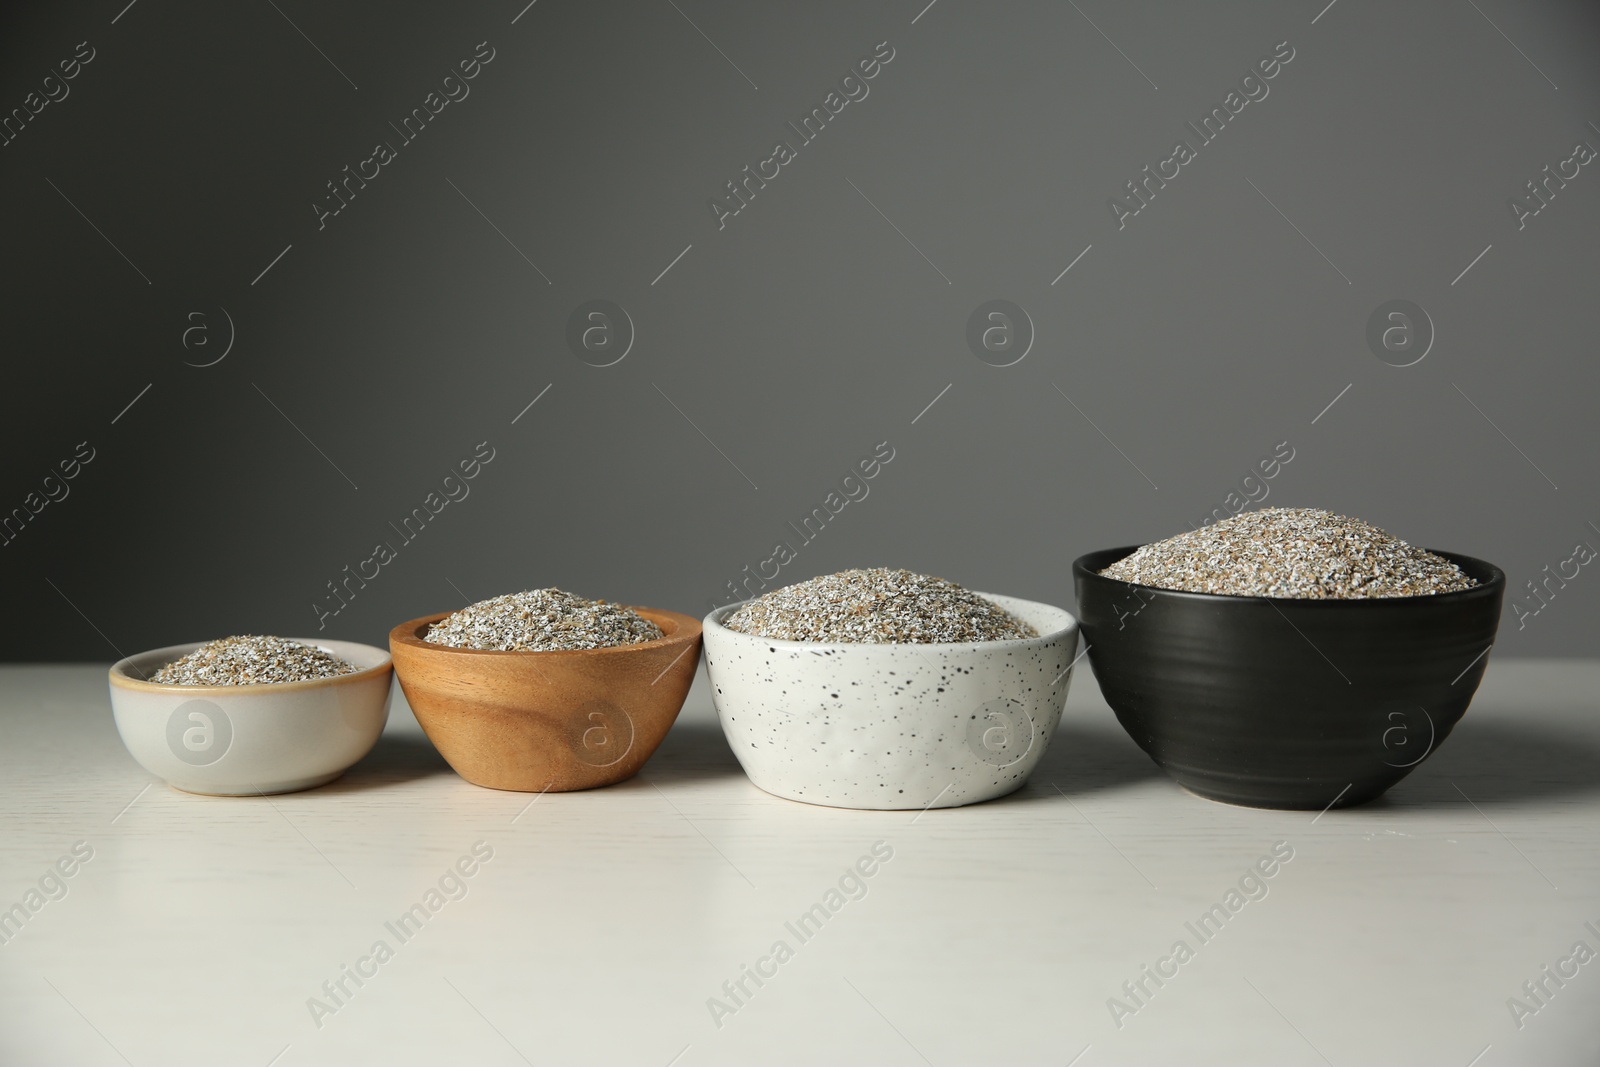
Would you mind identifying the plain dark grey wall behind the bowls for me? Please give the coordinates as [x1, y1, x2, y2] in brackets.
[0, 0, 1600, 659]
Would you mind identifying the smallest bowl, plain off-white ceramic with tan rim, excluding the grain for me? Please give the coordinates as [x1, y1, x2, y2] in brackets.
[110, 637, 392, 797]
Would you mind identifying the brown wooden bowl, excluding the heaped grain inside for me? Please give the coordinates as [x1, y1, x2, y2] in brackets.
[389, 608, 701, 792]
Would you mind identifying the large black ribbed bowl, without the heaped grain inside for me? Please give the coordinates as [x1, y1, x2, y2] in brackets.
[1072, 547, 1506, 809]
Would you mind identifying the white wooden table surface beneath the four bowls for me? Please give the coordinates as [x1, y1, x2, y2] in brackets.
[0, 661, 1600, 1067]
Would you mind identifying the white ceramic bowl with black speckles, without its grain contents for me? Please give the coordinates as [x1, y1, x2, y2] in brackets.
[704, 593, 1078, 809]
